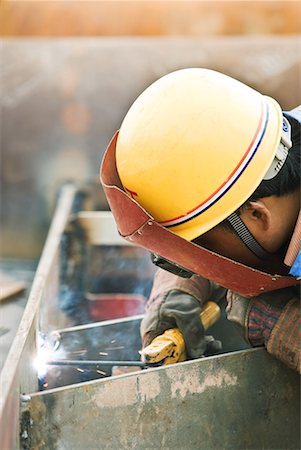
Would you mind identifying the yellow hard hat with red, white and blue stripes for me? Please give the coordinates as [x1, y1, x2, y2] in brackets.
[116, 68, 282, 240]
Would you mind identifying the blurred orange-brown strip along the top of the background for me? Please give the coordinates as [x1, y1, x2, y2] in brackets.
[0, 0, 300, 37]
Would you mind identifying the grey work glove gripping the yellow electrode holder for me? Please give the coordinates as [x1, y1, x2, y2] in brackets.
[141, 290, 209, 358]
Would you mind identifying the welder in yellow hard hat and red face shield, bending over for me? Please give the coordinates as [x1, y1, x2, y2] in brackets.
[101, 68, 301, 371]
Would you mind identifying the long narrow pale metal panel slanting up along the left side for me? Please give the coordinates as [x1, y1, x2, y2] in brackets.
[0, 185, 75, 450]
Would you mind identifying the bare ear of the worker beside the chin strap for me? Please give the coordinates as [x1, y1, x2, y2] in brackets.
[240, 200, 272, 232]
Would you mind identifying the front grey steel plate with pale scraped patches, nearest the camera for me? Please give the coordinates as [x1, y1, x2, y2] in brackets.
[21, 349, 300, 450]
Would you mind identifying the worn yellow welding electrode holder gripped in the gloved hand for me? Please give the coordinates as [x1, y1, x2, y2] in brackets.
[140, 301, 220, 365]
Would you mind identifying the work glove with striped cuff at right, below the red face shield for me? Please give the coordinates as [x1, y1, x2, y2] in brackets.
[226, 289, 292, 347]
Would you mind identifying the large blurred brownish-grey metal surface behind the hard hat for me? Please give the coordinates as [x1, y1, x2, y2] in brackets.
[0, 35, 301, 257]
